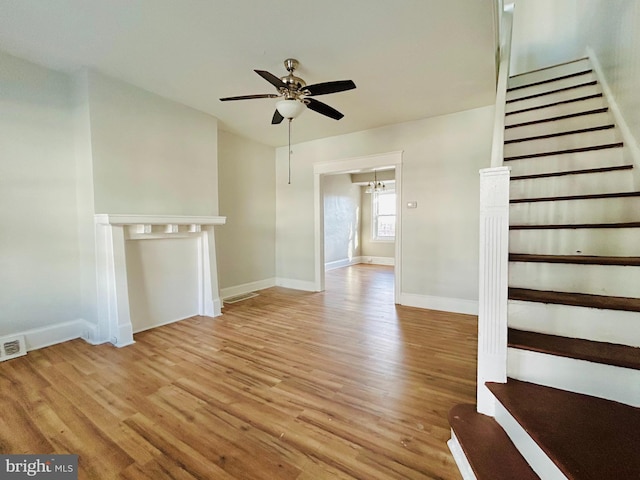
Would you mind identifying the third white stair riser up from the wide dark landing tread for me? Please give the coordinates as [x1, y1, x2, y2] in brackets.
[509, 262, 640, 298]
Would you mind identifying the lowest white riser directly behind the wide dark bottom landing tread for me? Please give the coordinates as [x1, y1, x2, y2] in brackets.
[507, 348, 640, 407]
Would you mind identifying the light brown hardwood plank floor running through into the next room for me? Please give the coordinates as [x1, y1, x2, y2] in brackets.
[0, 265, 477, 480]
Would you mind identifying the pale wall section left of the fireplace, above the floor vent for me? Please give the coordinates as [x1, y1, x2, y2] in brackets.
[0, 48, 81, 336]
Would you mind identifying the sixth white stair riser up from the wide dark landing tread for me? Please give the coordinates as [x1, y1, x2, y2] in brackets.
[509, 170, 634, 199]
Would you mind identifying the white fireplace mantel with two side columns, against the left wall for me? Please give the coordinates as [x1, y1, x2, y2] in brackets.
[94, 213, 226, 347]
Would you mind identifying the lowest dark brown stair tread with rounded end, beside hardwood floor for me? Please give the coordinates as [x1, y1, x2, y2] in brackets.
[449, 404, 539, 480]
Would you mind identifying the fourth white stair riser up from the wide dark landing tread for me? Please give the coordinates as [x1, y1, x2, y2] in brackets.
[509, 228, 640, 257]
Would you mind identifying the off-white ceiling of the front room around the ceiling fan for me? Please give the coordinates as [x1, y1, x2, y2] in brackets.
[0, 0, 497, 146]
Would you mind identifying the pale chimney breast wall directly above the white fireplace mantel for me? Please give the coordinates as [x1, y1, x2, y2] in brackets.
[88, 72, 218, 215]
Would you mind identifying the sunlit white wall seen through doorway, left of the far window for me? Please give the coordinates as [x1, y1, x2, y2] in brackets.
[322, 174, 362, 264]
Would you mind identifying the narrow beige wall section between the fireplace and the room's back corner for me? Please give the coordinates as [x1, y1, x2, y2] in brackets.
[216, 131, 276, 297]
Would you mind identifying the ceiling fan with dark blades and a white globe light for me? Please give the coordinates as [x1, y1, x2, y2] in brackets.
[220, 58, 356, 125]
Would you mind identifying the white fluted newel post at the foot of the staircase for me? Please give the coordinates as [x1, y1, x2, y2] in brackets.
[477, 167, 509, 416]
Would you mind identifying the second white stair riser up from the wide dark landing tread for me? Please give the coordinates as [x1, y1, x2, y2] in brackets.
[508, 300, 640, 347]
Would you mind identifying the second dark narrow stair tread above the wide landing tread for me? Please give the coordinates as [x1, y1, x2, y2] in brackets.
[509, 287, 640, 312]
